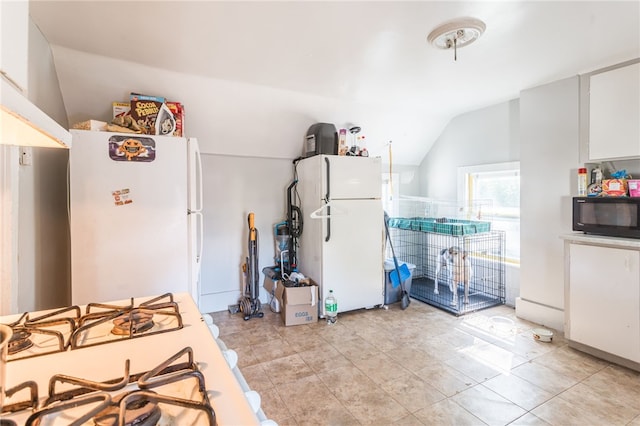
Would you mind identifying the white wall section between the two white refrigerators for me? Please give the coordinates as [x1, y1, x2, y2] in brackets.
[200, 155, 296, 312]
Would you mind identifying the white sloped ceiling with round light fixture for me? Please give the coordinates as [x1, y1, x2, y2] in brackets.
[30, 0, 640, 165]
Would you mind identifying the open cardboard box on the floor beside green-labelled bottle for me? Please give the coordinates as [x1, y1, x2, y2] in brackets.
[275, 284, 318, 326]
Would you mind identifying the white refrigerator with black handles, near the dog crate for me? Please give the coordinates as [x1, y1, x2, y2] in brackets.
[296, 155, 384, 317]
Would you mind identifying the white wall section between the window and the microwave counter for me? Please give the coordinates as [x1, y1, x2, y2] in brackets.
[516, 76, 581, 330]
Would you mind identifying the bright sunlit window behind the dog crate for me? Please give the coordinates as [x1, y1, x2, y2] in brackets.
[458, 162, 520, 263]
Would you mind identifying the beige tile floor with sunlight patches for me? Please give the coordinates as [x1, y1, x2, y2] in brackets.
[212, 300, 640, 426]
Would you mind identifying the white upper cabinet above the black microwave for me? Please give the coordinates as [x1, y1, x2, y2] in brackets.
[582, 61, 640, 161]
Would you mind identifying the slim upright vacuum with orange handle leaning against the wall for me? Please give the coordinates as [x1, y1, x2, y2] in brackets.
[229, 213, 264, 321]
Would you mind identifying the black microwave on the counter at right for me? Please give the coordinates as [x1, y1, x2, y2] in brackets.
[573, 197, 640, 238]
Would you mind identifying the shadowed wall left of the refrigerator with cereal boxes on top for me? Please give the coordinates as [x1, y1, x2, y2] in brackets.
[10, 21, 70, 312]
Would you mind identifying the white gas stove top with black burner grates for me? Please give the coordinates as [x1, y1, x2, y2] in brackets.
[0, 293, 259, 426]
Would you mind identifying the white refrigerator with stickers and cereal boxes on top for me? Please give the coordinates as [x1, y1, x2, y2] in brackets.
[69, 130, 203, 305]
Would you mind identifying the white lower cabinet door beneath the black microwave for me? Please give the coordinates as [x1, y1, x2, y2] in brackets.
[569, 244, 640, 362]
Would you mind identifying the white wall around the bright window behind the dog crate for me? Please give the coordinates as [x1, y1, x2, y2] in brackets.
[419, 99, 520, 306]
